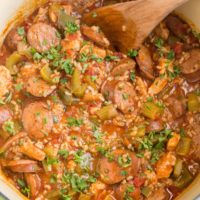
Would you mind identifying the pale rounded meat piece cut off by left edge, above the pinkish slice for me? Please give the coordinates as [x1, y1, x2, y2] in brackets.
[0, 65, 12, 98]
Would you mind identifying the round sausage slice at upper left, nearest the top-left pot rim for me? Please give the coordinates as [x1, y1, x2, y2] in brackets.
[27, 23, 60, 52]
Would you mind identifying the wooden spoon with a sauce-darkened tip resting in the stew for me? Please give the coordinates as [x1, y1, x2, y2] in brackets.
[82, 0, 188, 53]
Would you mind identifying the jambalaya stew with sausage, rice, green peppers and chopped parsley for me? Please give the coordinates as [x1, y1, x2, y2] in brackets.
[0, 1, 200, 200]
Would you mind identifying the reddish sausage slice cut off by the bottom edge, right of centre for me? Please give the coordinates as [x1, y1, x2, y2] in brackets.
[116, 183, 141, 200]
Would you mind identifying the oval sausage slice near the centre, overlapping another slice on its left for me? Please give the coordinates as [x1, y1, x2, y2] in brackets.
[113, 81, 136, 113]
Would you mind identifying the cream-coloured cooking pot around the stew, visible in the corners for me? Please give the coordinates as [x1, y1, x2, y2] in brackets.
[0, 0, 200, 200]
